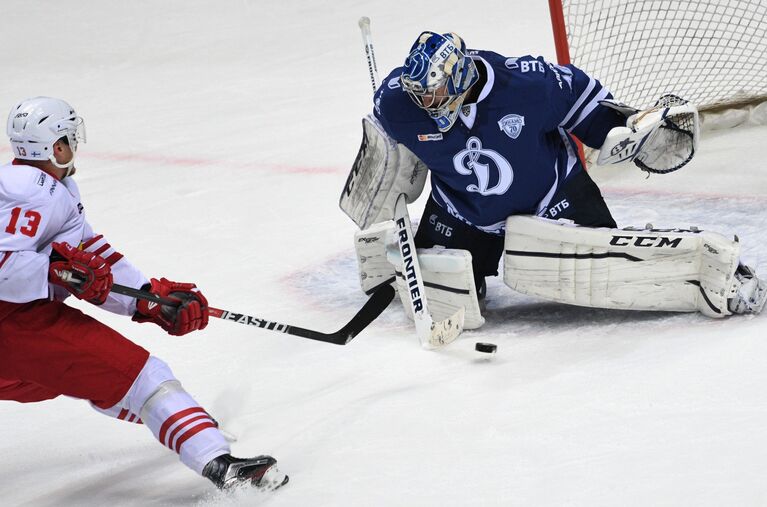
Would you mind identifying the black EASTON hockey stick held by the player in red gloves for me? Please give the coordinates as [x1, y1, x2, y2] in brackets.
[111, 283, 394, 345]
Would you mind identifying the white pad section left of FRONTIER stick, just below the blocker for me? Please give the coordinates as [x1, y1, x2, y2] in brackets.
[354, 220, 394, 295]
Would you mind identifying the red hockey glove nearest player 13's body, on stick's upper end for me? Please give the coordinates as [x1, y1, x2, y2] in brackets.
[48, 243, 112, 305]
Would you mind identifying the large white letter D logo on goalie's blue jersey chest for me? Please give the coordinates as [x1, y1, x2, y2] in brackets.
[453, 137, 514, 195]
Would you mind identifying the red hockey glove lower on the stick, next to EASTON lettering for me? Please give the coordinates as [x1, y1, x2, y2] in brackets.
[133, 278, 208, 336]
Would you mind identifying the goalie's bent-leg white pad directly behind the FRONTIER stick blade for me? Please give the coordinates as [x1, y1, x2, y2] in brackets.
[387, 248, 485, 329]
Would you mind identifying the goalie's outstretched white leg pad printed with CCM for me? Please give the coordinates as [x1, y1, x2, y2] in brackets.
[504, 216, 740, 317]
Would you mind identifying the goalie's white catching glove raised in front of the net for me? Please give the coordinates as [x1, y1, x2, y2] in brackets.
[597, 95, 699, 174]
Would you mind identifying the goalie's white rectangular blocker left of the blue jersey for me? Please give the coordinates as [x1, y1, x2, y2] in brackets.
[338, 115, 427, 229]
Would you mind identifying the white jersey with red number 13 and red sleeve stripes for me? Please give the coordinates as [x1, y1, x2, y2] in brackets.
[0, 160, 147, 315]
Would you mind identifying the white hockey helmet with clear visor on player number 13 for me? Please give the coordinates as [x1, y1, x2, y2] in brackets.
[7, 97, 85, 169]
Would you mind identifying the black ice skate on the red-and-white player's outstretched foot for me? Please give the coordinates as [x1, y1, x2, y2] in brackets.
[202, 454, 288, 491]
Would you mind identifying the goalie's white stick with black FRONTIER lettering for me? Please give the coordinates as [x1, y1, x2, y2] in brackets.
[358, 16, 466, 348]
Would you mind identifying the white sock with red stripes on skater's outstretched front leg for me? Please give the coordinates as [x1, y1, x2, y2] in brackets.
[110, 356, 230, 474]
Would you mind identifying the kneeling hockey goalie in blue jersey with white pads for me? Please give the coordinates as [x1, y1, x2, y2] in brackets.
[340, 32, 767, 336]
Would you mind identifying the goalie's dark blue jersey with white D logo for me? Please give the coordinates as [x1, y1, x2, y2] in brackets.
[374, 50, 626, 234]
